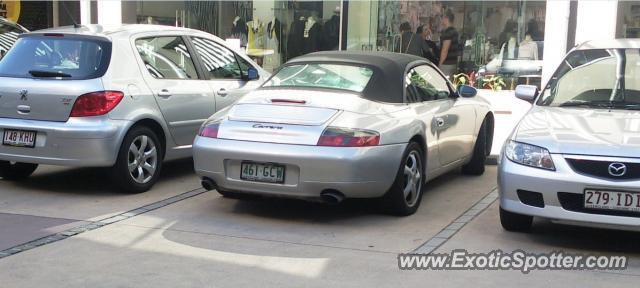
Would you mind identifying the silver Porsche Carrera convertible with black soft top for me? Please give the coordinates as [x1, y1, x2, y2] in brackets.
[193, 52, 494, 215]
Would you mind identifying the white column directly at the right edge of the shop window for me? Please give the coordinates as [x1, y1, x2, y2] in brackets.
[542, 0, 568, 85]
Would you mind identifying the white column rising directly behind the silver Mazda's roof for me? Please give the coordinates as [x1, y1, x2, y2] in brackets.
[572, 0, 618, 45]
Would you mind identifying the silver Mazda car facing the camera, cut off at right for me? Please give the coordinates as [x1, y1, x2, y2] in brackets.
[498, 40, 640, 231]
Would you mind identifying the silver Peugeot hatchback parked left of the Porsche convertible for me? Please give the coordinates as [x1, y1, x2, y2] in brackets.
[0, 25, 268, 193]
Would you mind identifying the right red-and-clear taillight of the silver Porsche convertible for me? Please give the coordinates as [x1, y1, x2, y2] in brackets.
[318, 127, 380, 147]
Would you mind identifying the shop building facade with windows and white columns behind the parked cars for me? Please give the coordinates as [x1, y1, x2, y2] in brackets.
[0, 0, 640, 89]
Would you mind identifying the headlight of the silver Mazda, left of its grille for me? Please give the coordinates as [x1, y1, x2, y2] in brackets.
[504, 141, 556, 171]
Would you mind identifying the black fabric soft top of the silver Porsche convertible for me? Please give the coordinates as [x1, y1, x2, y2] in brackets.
[284, 51, 429, 103]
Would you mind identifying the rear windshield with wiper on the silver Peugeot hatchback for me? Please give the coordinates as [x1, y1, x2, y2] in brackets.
[0, 34, 111, 80]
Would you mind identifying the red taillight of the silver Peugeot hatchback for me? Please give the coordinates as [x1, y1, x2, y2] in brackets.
[70, 91, 124, 117]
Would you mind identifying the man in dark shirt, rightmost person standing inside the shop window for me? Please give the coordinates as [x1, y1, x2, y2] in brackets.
[438, 10, 460, 76]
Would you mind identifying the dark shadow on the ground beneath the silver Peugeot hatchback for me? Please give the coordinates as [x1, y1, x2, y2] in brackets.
[5, 158, 194, 195]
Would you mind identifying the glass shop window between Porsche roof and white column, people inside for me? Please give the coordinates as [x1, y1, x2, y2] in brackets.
[376, 0, 546, 89]
